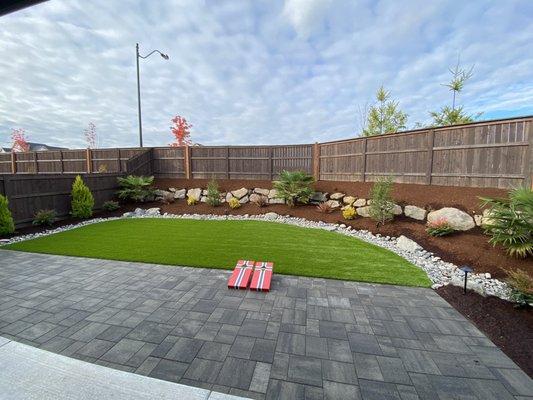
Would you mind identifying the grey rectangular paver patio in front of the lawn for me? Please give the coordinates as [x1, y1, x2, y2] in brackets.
[0, 250, 533, 400]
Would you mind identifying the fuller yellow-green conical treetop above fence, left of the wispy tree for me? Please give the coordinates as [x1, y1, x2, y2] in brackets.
[363, 86, 407, 136]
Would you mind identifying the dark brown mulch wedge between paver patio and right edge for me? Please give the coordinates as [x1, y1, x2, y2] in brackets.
[437, 286, 533, 378]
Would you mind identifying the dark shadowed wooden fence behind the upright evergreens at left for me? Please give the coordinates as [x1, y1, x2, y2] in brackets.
[0, 174, 120, 225]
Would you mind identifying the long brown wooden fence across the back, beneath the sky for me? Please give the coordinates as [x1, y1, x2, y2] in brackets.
[0, 117, 533, 188]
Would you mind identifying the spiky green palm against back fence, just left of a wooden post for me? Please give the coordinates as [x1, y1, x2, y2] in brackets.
[273, 171, 315, 207]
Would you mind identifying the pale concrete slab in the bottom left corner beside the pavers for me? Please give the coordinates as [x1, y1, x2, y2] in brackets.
[0, 337, 244, 400]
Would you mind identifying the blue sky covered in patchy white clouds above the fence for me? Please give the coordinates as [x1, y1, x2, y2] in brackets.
[0, 0, 533, 147]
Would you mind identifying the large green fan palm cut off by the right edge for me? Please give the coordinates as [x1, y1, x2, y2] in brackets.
[481, 188, 533, 258]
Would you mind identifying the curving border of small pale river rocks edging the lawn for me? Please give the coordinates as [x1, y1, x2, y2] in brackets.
[0, 207, 510, 300]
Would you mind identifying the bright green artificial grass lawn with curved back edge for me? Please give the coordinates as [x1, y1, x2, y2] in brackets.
[5, 218, 430, 286]
